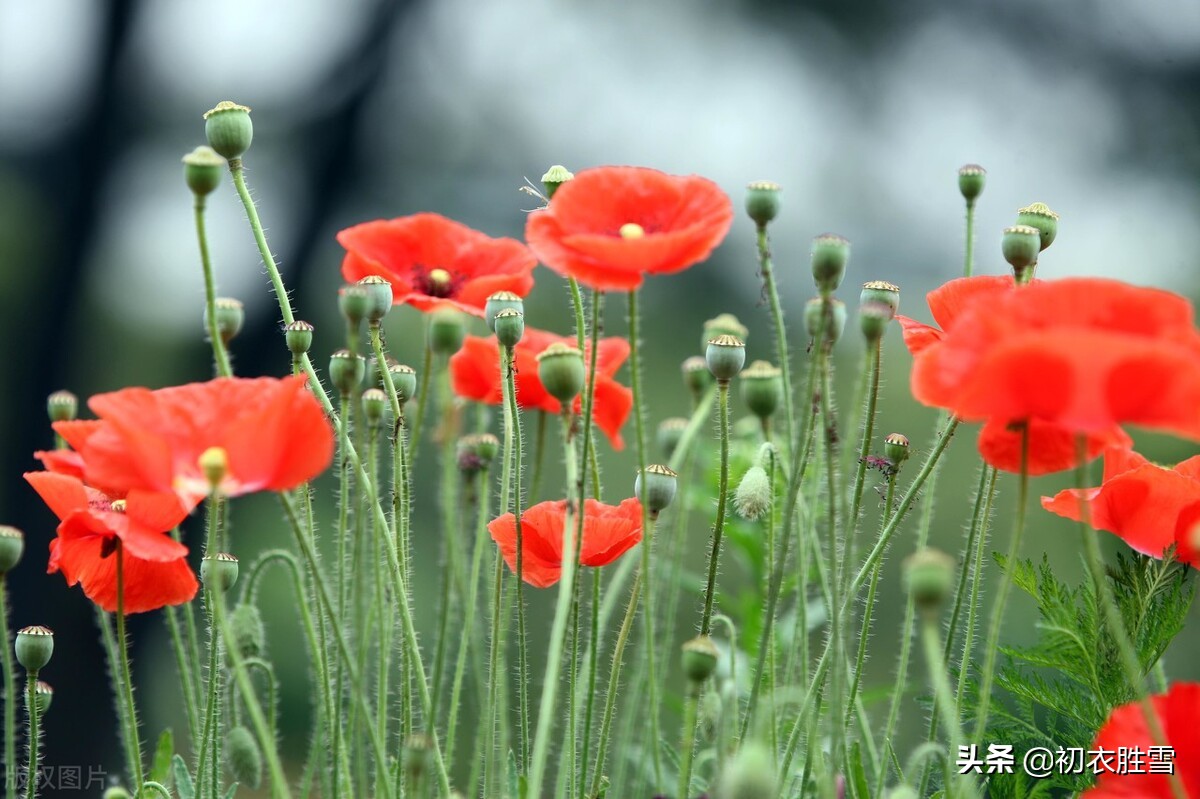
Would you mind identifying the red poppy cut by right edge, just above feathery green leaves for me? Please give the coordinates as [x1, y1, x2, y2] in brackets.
[1042, 449, 1200, 565]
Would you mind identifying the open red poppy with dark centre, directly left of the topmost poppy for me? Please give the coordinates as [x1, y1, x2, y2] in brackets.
[337, 214, 538, 317]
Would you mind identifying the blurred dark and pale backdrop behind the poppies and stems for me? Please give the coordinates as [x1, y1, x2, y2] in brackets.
[0, 0, 1200, 787]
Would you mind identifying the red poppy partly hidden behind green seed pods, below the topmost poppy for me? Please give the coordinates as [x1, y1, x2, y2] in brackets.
[450, 328, 634, 450]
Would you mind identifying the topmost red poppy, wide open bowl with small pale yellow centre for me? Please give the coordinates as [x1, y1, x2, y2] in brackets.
[526, 167, 733, 290]
